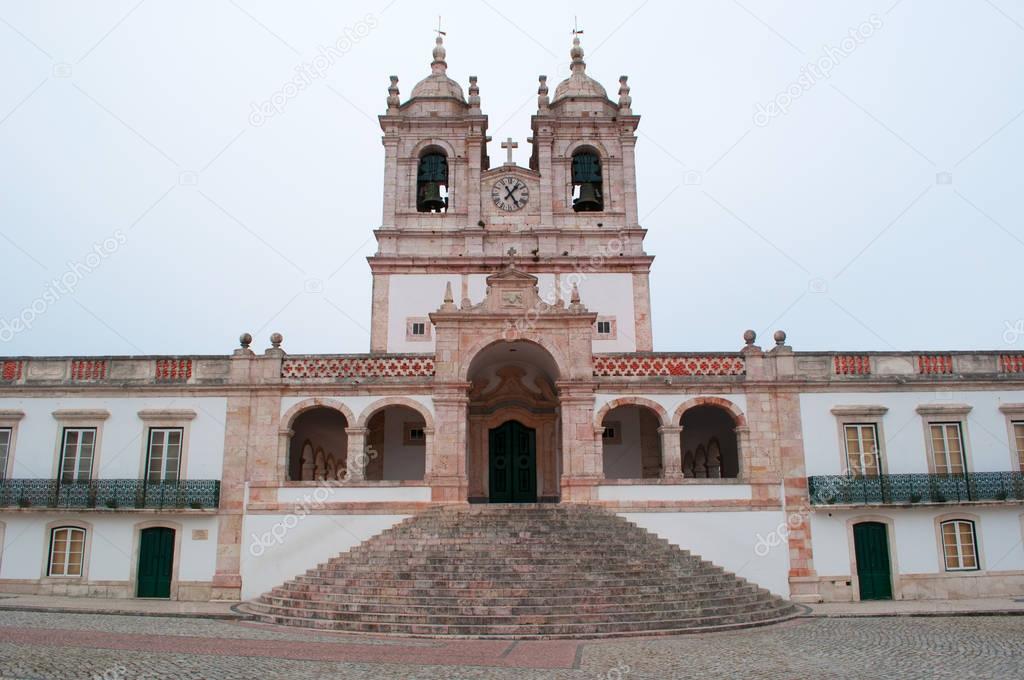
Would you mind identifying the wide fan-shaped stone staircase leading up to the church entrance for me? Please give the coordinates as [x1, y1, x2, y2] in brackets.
[241, 505, 797, 638]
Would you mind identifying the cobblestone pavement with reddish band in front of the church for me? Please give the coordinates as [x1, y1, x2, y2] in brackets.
[0, 611, 1024, 680]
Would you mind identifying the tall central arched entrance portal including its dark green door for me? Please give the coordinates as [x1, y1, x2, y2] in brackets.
[467, 340, 561, 503]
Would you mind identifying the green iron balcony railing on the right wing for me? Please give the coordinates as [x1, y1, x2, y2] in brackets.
[807, 472, 1024, 505]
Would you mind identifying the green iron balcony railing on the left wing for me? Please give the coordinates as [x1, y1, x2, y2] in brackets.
[0, 479, 220, 510]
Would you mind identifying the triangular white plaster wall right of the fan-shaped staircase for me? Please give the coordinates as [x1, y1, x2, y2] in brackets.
[620, 511, 790, 597]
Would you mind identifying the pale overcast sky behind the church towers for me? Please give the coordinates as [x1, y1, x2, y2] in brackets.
[0, 0, 1024, 355]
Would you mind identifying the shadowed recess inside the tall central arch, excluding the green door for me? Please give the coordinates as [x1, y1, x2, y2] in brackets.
[466, 340, 561, 503]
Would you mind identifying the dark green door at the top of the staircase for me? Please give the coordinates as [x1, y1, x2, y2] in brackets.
[488, 420, 537, 503]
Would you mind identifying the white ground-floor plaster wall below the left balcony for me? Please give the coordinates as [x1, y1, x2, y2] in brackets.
[0, 512, 217, 581]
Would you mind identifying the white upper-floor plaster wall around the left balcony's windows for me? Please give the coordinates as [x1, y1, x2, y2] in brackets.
[0, 396, 227, 479]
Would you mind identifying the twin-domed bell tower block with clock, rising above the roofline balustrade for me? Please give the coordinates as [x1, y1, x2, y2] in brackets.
[368, 30, 653, 352]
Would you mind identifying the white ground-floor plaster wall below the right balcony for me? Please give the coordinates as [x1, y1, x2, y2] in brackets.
[811, 506, 1024, 577]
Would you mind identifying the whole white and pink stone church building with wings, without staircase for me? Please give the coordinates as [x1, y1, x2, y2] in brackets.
[0, 38, 1024, 601]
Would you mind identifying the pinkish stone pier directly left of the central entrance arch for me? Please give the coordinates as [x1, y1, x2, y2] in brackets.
[427, 383, 469, 503]
